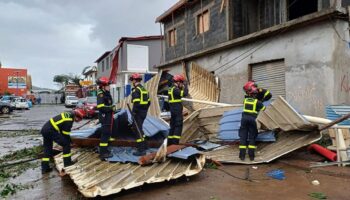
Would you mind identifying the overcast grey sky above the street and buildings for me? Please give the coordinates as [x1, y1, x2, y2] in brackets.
[0, 0, 178, 89]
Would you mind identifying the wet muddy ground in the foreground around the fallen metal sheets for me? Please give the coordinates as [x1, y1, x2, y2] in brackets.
[0, 105, 350, 200]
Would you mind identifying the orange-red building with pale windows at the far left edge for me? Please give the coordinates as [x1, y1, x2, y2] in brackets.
[0, 67, 27, 96]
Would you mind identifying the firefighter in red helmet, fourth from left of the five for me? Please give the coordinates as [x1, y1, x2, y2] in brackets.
[168, 75, 188, 145]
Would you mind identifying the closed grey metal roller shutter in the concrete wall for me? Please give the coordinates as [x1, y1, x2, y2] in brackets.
[252, 60, 286, 99]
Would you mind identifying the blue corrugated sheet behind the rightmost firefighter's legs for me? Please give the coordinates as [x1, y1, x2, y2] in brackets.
[218, 109, 276, 142]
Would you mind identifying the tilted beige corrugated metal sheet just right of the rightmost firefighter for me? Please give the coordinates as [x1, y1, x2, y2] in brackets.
[257, 96, 315, 131]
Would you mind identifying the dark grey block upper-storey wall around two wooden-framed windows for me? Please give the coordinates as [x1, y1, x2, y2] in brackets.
[164, 0, 228, 61]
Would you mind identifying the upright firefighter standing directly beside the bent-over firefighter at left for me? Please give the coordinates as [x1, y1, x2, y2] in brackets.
[96, 77, 115, 160]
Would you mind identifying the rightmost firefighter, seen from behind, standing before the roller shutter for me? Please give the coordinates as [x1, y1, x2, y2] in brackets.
[239, 83, 265, 161]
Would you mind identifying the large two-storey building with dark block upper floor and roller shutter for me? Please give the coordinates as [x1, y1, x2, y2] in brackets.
[156, 0, 350, 117]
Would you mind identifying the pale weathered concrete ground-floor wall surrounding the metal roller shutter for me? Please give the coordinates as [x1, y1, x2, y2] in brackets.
[166, 20, 350, 116]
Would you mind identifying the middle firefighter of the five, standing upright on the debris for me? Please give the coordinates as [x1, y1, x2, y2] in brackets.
[129, 73, 151, 156]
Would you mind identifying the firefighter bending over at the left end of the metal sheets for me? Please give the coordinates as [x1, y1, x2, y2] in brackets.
[41, 109, 85, 174]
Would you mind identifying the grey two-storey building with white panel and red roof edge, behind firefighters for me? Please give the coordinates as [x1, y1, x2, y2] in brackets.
[96, 36, 163, 102]
